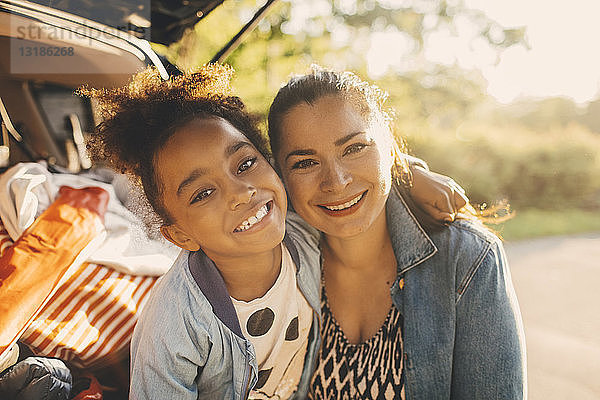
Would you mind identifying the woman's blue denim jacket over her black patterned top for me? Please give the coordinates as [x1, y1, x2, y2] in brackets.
[386, 188, 527, 400]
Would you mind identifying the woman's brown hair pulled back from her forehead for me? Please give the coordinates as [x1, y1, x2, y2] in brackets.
[268, 65, 443, 231]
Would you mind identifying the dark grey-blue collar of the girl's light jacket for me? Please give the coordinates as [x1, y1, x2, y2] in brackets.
[188, 234, 300, 338]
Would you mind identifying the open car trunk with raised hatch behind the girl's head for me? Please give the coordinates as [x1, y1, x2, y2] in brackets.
[0, 0, 275, 172]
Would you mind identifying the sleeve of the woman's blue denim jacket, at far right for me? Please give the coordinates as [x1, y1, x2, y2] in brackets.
[452, 238, 527, 399]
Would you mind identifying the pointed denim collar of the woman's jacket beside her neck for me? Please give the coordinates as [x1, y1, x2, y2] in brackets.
[386, 186, 438, 275]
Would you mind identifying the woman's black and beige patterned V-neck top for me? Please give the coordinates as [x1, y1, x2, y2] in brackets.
[310, 286, 405, 400]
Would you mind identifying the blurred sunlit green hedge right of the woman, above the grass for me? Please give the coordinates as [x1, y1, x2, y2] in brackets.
[408, 124, 600, 212]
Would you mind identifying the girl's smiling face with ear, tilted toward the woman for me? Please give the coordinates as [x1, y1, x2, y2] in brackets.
[154, 118, 287, 259]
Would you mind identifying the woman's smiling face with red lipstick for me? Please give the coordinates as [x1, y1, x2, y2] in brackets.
[275, 95, 393, 237]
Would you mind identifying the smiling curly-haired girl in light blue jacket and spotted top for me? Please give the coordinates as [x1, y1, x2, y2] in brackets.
[83, 66, 468, 399]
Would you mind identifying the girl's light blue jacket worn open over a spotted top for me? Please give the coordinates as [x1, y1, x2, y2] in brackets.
[129, 213, 321, 400]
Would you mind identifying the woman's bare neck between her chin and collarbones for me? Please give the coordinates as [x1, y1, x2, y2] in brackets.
[322, 208, 393, 270]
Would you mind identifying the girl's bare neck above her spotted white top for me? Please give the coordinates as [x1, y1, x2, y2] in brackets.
[209, 245, 282, 301]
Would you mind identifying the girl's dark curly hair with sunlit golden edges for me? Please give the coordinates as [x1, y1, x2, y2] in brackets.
[78, 64, 269, 224]
